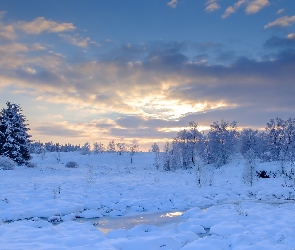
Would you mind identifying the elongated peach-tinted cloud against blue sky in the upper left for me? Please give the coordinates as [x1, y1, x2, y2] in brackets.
[14, 17, 76, 35]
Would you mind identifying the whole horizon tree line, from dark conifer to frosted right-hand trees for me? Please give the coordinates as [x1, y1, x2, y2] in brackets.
[0, 102, 295, 173]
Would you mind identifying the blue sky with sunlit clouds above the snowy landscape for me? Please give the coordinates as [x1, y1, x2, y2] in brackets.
[0, 0, 295, 150]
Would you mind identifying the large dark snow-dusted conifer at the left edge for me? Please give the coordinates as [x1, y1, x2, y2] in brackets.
[0, 102, 31, 165]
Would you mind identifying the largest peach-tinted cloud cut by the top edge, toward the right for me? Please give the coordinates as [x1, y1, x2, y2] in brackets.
[221, 0, 270, 18]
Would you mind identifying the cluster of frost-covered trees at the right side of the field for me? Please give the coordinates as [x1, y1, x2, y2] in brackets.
[163, 117, 295, 172]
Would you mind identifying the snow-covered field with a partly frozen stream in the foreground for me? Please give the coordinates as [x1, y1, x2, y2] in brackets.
[0, 153, 295, 250]
